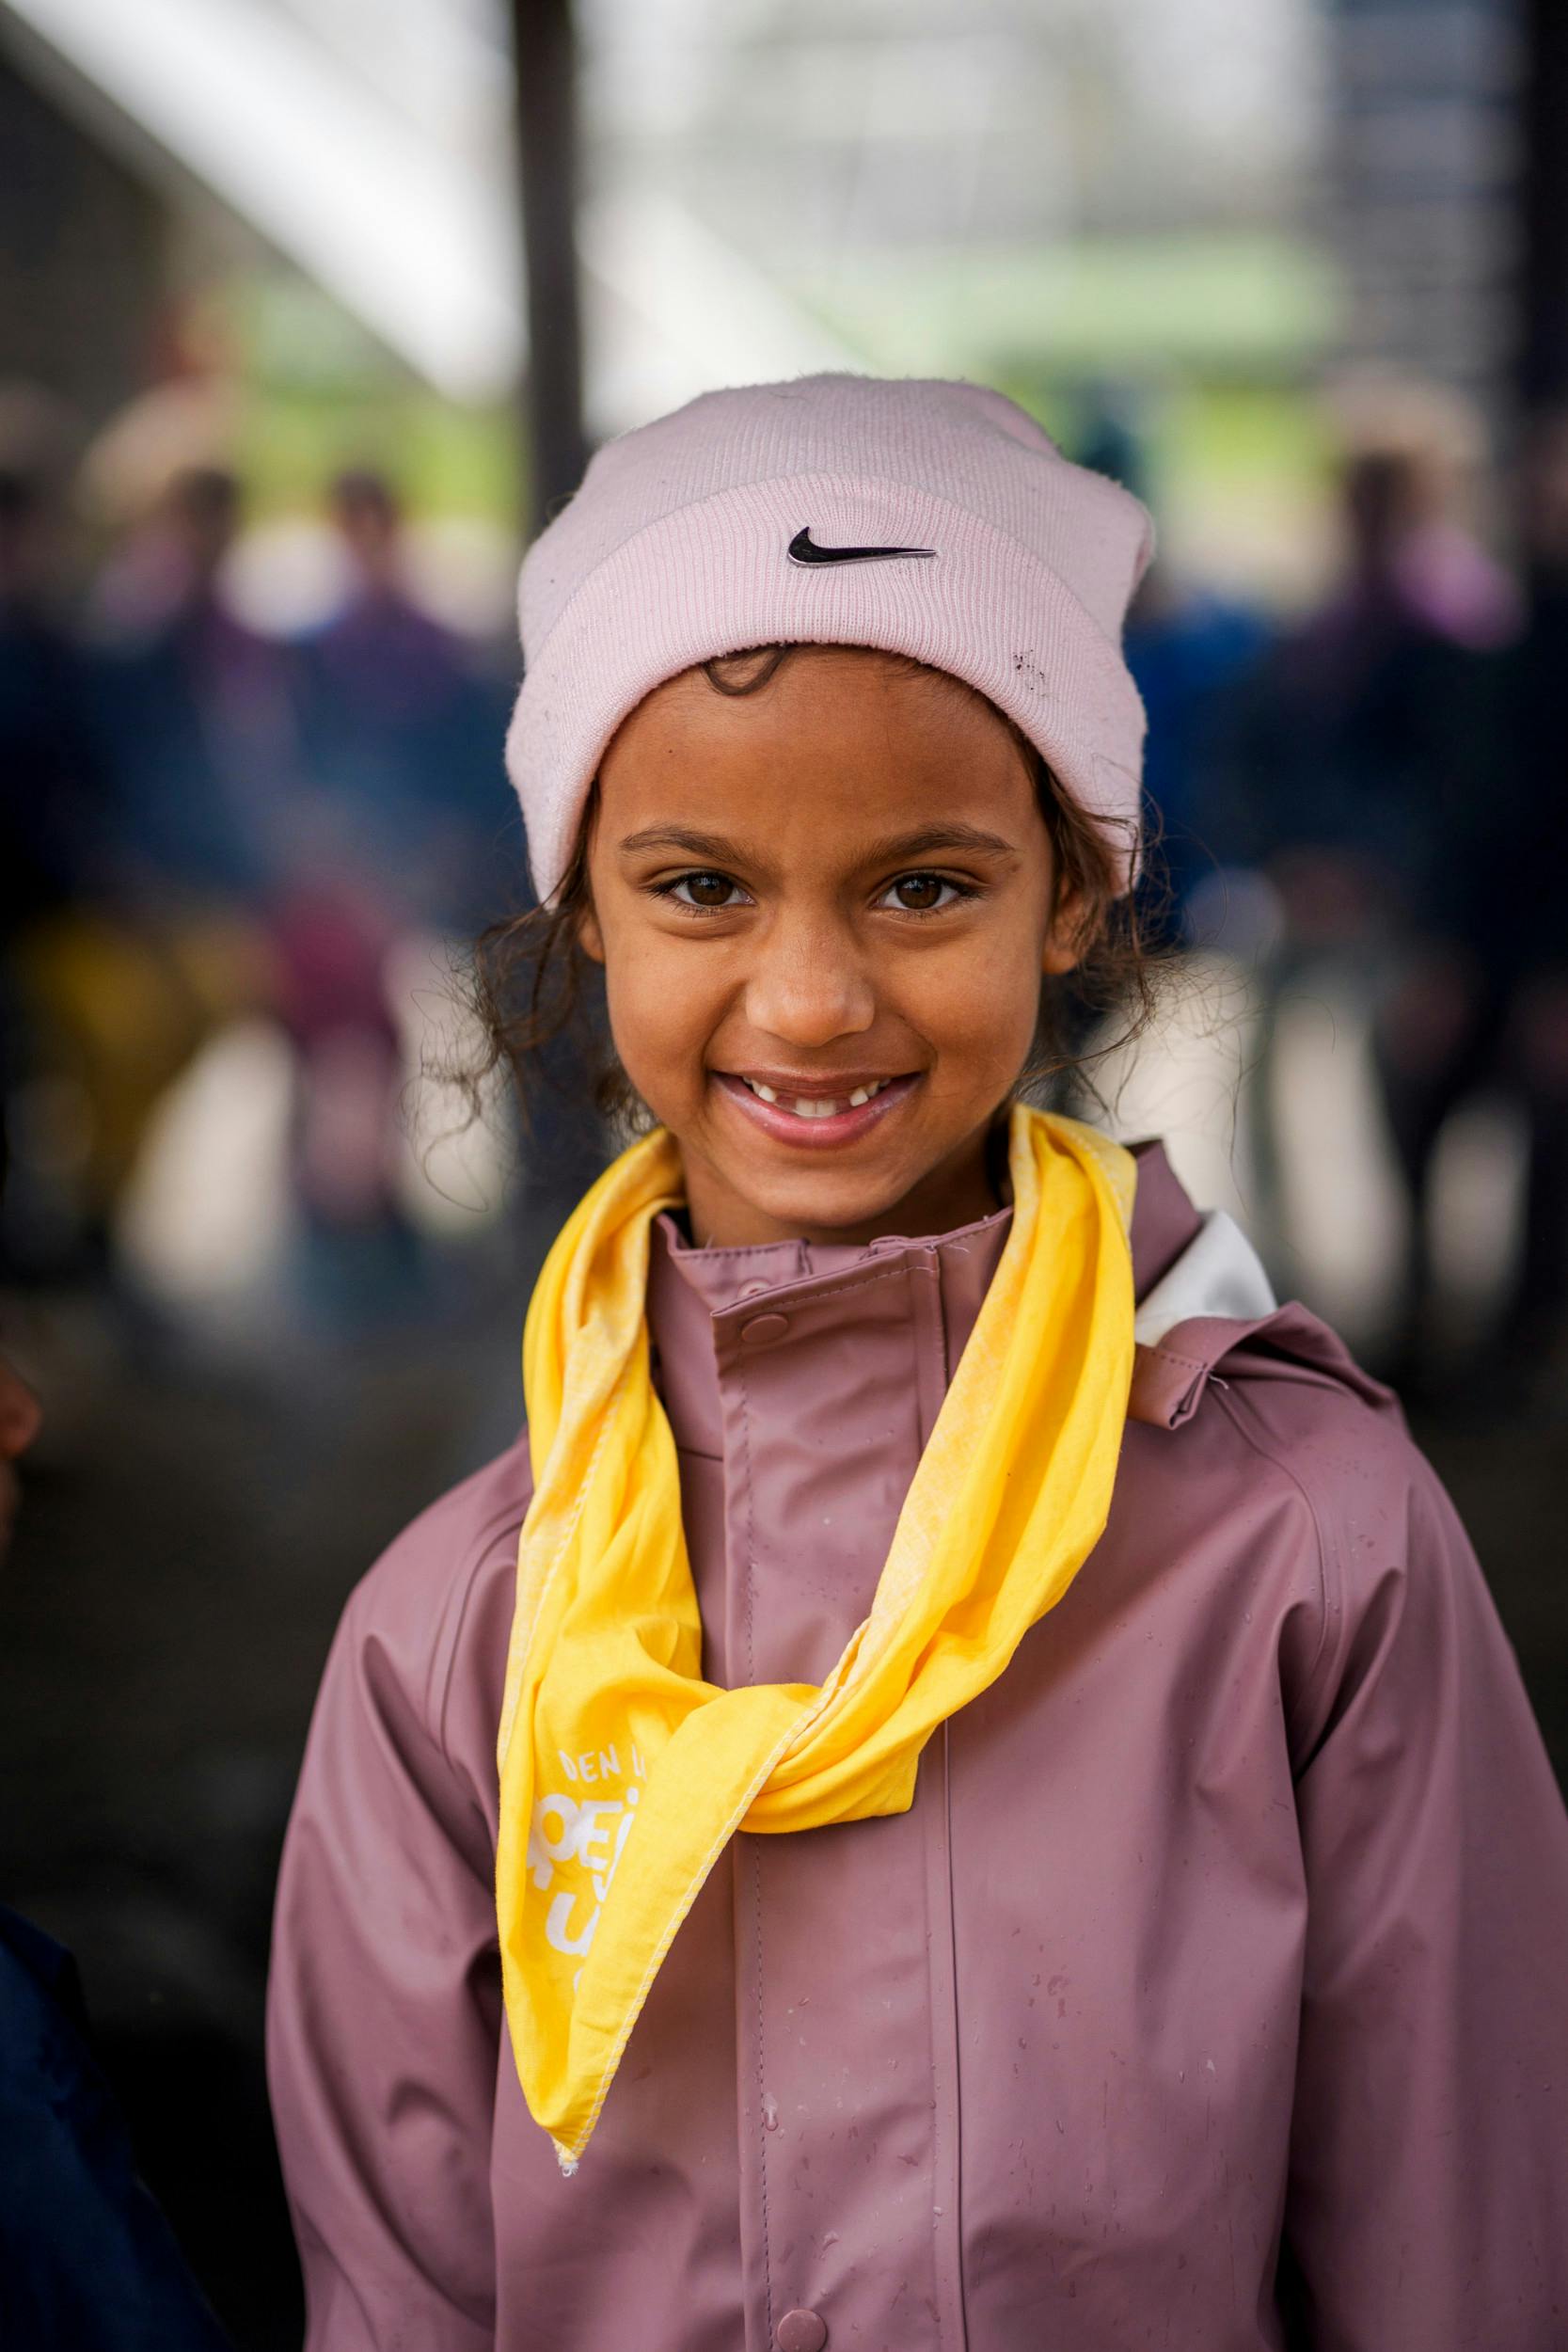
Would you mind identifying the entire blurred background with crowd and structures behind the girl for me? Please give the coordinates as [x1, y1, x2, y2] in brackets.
[0, 0, 1568, 2352]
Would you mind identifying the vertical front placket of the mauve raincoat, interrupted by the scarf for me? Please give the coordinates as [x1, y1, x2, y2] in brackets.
[715, 1245, 964, 2352]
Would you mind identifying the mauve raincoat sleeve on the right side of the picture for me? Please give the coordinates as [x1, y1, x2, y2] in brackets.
[1281, 1442, 1568, 2352]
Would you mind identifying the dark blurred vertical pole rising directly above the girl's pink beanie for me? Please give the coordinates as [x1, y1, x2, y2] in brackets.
[510, 0, 588, 532]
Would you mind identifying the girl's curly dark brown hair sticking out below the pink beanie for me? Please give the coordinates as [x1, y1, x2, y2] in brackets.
[447, 644, 1168, 1132]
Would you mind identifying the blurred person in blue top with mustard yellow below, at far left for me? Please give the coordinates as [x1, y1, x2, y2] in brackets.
[7, 449, 277, 1292]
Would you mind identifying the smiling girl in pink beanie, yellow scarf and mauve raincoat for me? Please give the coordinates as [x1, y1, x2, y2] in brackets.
[270, 376, 1568, 2352]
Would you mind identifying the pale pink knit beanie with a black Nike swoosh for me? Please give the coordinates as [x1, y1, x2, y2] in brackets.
[505, 376, 1154, 901]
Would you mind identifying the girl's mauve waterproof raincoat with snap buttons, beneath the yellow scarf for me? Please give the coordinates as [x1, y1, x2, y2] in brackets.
[268, 1143, 1568, 2352]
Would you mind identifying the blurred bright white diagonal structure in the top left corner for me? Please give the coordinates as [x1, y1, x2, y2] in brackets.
[0, 0, 519, 400]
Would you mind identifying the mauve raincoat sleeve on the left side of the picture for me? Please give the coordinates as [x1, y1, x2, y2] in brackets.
[268, 1522, 505, 2352]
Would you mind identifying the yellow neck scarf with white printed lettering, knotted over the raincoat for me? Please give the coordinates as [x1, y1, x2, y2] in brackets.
[496, 1105, 1135, 2171]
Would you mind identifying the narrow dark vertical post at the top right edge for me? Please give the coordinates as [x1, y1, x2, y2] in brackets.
[1519, 0, 1568, 417]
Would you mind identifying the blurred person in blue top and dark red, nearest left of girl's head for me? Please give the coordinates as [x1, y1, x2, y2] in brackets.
[268, 466, 517, 1325]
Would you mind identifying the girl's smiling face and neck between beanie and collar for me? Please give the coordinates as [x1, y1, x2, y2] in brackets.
[580, 647, 1074, 1245]
